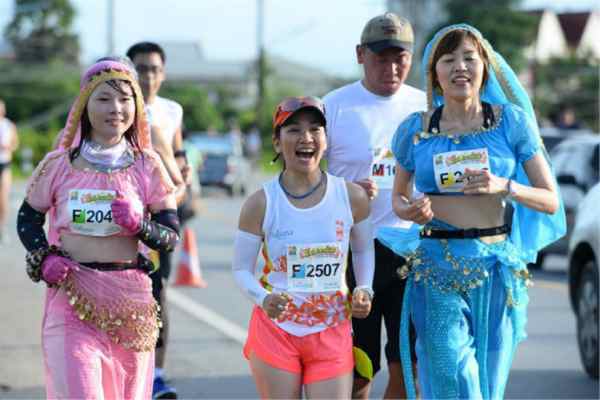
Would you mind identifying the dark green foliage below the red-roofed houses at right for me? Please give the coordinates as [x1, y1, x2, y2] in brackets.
[534, 57, 600, 132]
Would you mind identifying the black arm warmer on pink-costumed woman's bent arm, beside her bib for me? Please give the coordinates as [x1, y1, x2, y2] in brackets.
[137, 209, 179, 252]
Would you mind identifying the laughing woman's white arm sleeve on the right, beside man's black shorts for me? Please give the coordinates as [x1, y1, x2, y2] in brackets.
[350, 218, 375, 289]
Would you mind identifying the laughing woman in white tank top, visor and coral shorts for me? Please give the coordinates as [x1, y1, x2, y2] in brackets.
[233, 97, 374, 399]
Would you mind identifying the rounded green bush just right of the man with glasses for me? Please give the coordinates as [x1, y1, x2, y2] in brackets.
[160, 83, 224, 132]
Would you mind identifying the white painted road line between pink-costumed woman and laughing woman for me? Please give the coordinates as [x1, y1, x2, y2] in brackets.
[167, 287, 247, 345]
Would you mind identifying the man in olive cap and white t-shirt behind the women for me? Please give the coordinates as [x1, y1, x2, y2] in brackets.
[324, 13, 426, 399]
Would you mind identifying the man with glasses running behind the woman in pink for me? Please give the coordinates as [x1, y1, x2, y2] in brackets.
[127, 42, 189, 399]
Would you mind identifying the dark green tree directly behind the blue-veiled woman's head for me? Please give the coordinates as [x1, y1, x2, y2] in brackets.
[430, 0, 537, 71]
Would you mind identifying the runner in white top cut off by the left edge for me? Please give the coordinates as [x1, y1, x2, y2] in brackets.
[0, 99, 19, 243]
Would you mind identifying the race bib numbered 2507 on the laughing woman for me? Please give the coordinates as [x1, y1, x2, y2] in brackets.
[287, 242, 345, 292]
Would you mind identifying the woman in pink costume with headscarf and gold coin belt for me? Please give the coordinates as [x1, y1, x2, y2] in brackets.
[17, 60, 179, 399]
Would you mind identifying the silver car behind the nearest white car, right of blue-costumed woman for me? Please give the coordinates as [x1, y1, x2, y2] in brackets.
[530, 133, 600, 269]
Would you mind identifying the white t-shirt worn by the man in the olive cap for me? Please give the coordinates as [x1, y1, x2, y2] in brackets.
[323, 81, 427, 236]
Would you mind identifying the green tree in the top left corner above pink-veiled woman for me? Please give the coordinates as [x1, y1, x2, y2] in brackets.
[4, 0, 79, 64]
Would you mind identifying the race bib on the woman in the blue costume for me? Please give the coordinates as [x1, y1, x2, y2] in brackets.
[433, 148, 490, 192]
